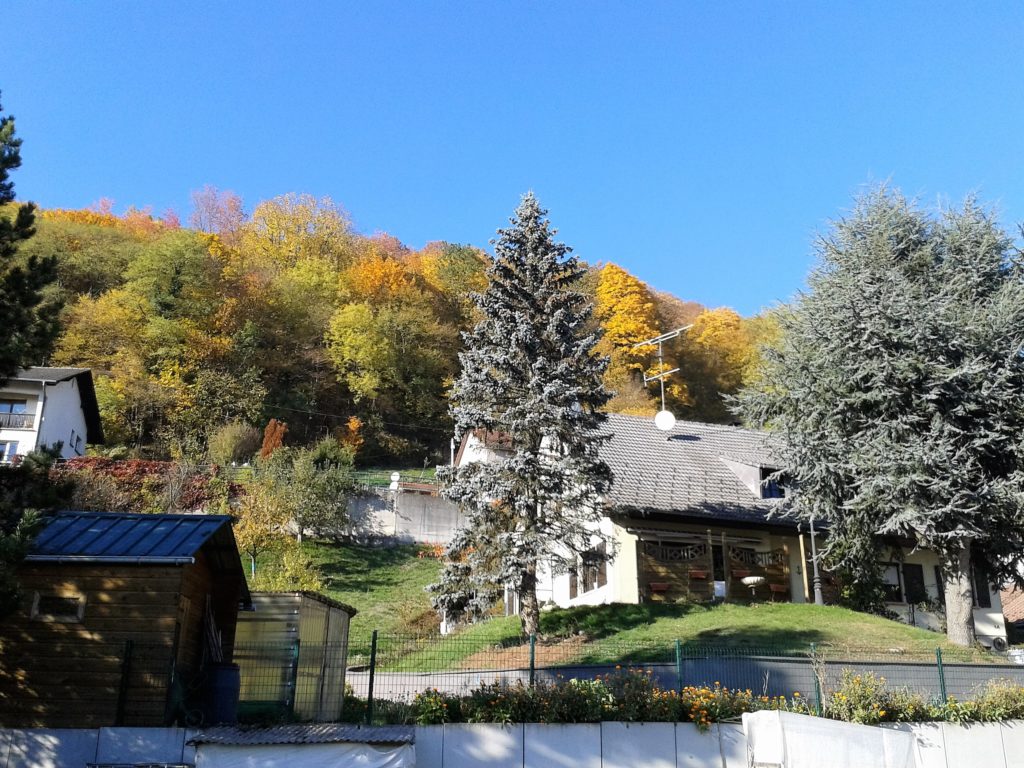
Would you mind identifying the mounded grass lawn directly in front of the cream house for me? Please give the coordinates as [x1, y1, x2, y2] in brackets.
[380, 603, 999, 671]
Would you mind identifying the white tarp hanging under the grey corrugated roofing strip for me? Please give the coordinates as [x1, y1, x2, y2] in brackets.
[196, 743, 416, 768]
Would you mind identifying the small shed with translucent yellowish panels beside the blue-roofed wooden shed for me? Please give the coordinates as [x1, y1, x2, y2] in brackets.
[236, 592, 355, 722]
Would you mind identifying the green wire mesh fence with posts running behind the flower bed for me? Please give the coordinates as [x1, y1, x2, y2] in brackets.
[228, 632, 1024, 721]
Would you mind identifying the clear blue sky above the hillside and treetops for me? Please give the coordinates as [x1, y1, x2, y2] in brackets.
[0, 0, 1024, 313]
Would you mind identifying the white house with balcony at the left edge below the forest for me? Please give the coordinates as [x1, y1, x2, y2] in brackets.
[0, 368, 103, 463]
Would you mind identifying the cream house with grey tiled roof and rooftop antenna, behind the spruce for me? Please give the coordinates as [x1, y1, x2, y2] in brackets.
[456, 414, 1006, 645]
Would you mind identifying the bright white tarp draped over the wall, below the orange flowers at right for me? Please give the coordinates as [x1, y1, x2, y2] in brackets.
[743, 711, 921, 768]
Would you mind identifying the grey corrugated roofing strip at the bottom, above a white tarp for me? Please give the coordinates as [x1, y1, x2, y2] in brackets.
[188, 723, 416, 746]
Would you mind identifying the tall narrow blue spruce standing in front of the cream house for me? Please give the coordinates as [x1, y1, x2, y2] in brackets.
[431, 194, 612, 633]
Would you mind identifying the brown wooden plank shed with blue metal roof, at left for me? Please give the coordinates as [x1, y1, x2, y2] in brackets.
[0, 512, 250, 728]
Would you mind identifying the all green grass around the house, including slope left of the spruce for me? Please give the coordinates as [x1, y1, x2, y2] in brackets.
[296, 543, 984, 669]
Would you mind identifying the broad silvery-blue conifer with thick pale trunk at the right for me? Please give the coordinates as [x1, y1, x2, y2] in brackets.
[738, 189, 1024, 645]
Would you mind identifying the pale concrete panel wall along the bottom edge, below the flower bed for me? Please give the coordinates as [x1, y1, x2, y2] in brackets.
[8, 721, 1024, 768]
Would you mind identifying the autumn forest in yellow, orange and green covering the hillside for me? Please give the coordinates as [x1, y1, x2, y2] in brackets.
[6, 195, 774, 466]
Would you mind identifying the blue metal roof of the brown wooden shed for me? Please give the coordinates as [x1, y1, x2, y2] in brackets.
[26, 512, 231, 563]
